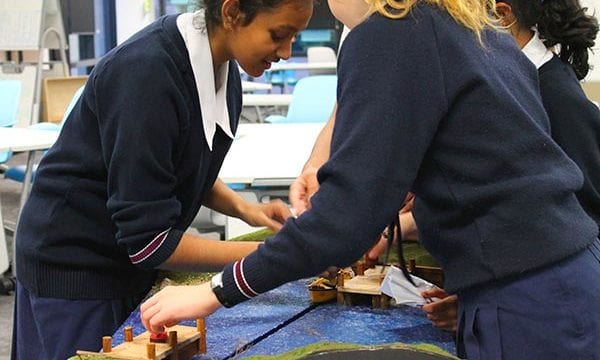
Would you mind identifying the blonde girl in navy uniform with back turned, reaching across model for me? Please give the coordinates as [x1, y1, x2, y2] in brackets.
[141, 0, 600, 359]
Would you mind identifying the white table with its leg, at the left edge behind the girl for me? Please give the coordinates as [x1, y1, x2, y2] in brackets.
[0, 128, 59, 275]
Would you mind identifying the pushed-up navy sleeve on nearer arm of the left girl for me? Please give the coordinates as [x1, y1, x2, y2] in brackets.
[94, 49, 186, 268]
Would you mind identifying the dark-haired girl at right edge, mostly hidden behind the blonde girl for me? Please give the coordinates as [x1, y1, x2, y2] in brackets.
[414, 0, 600, 334]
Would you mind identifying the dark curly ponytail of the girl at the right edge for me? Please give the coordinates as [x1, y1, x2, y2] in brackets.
[530, 0, 598, 80]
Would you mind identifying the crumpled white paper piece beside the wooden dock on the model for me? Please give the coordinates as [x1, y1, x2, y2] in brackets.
[380, 266, 435, 306]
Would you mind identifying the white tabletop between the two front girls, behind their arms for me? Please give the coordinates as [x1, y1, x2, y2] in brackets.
[219, 123, 325, 186]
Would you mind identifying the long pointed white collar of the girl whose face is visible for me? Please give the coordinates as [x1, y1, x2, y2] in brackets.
[177, 10, 233, 151]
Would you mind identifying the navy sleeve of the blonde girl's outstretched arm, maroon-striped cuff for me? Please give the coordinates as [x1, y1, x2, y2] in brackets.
[218, 16, 446, 304]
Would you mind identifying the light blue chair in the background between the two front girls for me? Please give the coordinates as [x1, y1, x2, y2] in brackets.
[265, 75, 337, 123]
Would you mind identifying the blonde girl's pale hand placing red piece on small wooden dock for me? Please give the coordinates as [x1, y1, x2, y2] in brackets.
[140, 282, 221, 333]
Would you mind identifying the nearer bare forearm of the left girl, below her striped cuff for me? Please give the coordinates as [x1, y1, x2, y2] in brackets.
[160, 233, 259, 272]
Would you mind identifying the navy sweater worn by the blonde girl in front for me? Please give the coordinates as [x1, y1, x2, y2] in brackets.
[218, 3, 598, 304]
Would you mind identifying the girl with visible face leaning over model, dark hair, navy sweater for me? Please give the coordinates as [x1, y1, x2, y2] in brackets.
[13, 0, 312, 360]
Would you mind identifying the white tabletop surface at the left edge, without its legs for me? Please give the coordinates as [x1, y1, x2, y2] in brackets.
[0, 127, 59, 152]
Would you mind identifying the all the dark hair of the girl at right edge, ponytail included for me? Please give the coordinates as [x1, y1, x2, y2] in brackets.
[498, 0, 598, 80]
